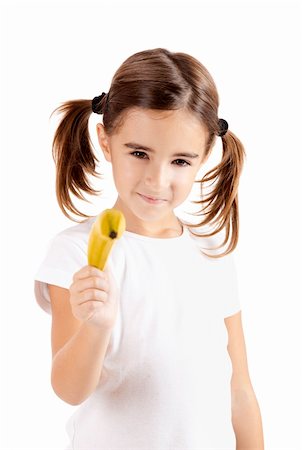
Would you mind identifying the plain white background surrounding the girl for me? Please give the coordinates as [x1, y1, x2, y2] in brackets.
[1, 0, 302, 450]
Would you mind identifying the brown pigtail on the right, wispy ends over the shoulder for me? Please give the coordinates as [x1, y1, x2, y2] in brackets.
[190, 131, 245, 258]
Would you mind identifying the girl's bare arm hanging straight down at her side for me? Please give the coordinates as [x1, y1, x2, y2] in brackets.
[224, 312, 264, 450]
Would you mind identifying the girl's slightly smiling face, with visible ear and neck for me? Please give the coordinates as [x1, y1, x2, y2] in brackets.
[97, 108, 207, 235]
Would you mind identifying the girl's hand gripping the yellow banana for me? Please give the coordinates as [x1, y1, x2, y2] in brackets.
[69, 266, 119, 329]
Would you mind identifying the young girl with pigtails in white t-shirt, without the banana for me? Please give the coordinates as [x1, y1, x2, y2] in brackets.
[35, 48, 263, 450]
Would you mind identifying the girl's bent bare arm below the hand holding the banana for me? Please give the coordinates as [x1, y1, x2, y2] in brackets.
[48, 285, 112, 405]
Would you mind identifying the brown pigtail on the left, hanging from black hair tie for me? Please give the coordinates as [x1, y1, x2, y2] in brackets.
[52, 100, 101, 222]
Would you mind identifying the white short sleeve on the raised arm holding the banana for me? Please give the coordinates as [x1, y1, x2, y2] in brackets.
[34, 233, 87, 314]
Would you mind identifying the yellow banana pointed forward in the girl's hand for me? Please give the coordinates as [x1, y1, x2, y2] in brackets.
[87, 208, 126, 270]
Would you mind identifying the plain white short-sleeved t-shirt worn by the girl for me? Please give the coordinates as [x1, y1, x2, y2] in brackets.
[35, 218, 241, 450]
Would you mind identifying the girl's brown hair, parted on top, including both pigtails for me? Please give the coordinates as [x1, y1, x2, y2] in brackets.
[53, 48, 245, 258]
